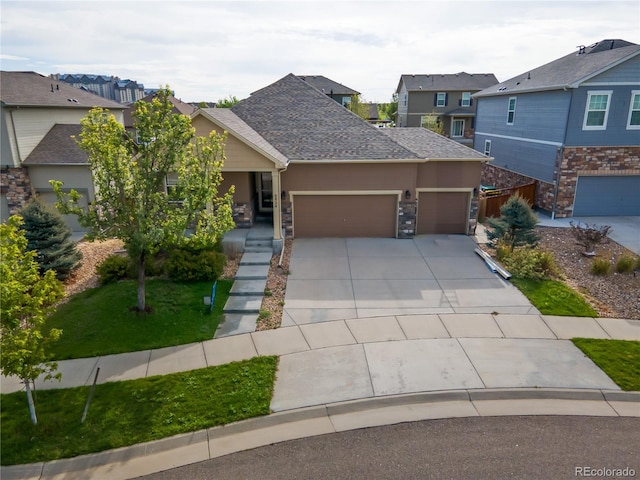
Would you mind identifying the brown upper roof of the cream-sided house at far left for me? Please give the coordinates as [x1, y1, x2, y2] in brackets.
[0, 71, 124, 109]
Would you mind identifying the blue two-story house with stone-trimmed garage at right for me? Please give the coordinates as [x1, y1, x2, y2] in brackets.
[474, 40, 640, 217]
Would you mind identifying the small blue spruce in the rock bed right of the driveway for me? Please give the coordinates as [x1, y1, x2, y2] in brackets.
[487, 195, 540, 250]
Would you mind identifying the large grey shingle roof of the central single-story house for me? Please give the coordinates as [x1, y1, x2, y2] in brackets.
[228, 74, 486, 162]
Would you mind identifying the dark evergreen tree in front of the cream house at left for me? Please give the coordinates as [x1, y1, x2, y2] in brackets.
[20, 200, 82, 280]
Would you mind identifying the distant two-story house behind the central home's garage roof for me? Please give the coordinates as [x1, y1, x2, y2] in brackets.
[396, 72, 498, 145]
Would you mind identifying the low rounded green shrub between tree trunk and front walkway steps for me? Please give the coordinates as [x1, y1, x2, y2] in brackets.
[165, 249, 227, 281]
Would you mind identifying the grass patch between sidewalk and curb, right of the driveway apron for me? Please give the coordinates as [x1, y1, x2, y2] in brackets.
[572, 338, 640, 391]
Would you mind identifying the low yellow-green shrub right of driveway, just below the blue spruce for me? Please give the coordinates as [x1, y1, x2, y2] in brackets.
[497, 247, 560, 280]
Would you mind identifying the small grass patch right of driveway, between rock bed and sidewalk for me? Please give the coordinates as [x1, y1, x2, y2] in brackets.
[511, 277, 598, 317]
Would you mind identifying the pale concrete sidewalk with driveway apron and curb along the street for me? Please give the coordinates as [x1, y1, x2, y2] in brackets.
[1, 314, 640, 479]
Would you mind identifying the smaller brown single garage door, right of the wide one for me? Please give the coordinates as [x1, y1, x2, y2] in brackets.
[417, 192, 469, 235]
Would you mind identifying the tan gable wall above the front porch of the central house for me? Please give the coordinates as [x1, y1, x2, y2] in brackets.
[192, 115, 275, 172]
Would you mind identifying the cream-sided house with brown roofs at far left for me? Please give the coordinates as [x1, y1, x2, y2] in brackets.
[0, 71, 124, 231]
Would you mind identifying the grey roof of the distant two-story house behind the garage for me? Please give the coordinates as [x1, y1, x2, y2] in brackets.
[396, 72, 498, 92]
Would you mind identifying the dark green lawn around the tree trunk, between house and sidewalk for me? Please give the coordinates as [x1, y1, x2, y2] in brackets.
[46, 279, 233, 360]
